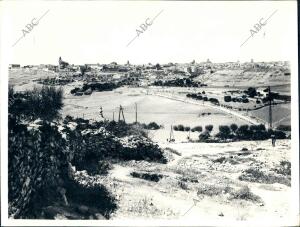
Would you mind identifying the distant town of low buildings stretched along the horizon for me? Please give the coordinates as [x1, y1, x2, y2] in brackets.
[9, 57, 289, 85]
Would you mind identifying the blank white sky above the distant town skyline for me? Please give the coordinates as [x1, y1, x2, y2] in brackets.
[0, 1, 297, 65]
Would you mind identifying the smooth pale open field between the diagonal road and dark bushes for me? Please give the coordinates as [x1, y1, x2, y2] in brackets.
[62, 88, 251, 141]
